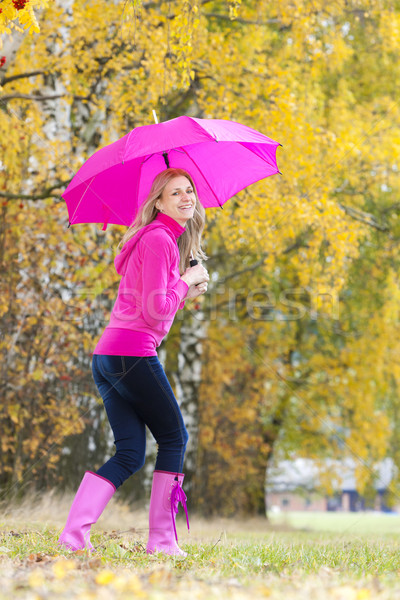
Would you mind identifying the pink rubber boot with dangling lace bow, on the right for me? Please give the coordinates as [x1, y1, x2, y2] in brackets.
[146, 471, 189, 556]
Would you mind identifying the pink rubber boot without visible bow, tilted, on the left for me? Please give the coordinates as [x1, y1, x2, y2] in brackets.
[58, 471, 116, 550]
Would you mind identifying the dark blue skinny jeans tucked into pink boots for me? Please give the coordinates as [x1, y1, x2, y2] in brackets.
[92, 354, 188, 488]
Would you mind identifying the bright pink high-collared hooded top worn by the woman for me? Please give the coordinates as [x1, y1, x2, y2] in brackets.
[93, 213, 189, 356]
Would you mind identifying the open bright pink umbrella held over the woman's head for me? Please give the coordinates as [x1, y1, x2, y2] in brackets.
[62, 117, 281, 229]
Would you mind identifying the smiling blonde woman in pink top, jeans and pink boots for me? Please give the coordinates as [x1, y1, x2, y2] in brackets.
[59, 169, 209, 556]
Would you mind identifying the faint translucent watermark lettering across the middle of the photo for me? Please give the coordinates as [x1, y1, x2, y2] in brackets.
[63, 285, 340, 328]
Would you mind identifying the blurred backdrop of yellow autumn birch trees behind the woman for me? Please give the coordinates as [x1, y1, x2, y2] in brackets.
[0, 0, 400, 517]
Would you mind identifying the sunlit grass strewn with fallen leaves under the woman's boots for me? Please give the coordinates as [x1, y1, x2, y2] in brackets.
[0, 497, 400, 600]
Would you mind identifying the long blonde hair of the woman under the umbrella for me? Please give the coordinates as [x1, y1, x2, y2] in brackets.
[118, 169, 208, 275]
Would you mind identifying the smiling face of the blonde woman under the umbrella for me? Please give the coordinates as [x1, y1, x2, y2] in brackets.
[156, 175, 196, 227]
